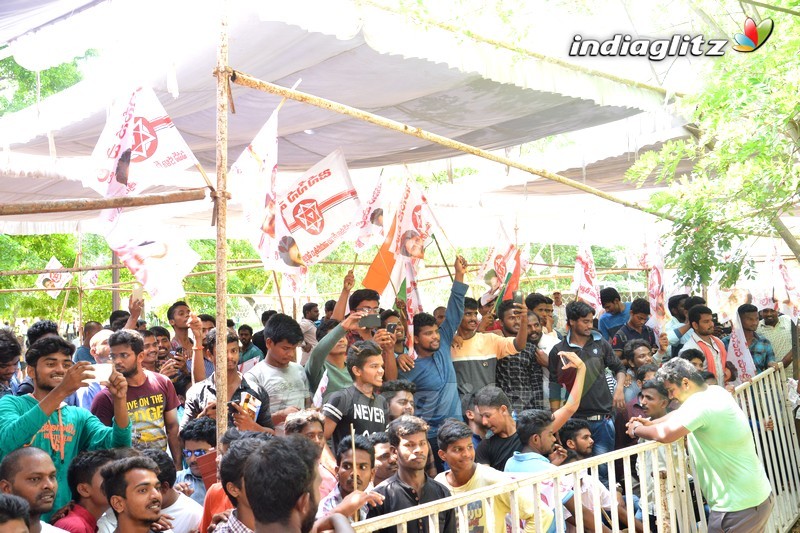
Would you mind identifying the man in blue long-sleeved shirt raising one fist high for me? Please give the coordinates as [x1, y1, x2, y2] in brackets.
[399, 256, 468, 472]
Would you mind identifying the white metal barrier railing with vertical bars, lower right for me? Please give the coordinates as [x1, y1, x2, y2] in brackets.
[353, 368, 800, 533]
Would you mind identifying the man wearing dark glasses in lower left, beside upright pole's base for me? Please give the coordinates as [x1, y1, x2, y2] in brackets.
[175, 416, 217, 505]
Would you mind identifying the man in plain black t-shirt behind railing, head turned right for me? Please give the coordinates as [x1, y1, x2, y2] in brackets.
[474, 385, 522, 472]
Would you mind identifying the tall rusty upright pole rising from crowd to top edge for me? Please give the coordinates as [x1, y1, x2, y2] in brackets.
[213, 0, 230, 436]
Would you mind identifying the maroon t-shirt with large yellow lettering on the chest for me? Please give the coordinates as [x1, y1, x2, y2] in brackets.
[91, 369, 180, 451]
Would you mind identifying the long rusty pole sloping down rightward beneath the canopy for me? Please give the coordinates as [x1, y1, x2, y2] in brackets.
[227, 69, 677, 222]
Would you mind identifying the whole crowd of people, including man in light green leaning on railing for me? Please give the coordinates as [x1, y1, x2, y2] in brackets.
[0, 257, 792, 533]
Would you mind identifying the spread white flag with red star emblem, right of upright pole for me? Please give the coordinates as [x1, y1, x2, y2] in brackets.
[276, 150, 361, 273]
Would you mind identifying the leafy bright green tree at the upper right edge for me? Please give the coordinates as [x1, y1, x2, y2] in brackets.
[628, 1, 800, 287]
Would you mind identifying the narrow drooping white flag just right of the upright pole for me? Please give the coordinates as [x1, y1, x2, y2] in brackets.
[230, 108, 279, 269]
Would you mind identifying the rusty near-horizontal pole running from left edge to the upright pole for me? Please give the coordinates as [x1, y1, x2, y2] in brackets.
[0, 185, 206, 216]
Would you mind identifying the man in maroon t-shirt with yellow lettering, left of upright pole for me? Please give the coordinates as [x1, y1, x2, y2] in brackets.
[91, 329, 183, 469]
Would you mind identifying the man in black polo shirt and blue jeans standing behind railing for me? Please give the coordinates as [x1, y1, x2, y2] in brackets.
[548, 302, 625, 485]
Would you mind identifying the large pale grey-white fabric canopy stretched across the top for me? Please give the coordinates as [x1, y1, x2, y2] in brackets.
[0, 0, 662, 171]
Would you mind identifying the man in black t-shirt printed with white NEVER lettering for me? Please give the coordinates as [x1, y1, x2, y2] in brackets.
[322, 341, 389, 449]
